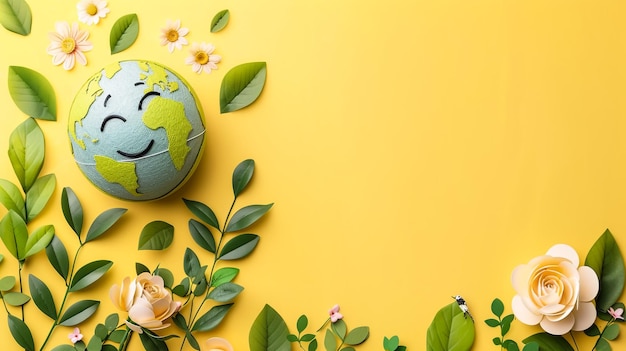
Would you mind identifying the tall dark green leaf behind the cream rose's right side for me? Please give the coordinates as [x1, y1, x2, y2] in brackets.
[585, 229, 625, 312]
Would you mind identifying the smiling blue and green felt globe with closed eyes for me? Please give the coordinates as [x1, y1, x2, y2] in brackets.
[68, 60, 205, 201]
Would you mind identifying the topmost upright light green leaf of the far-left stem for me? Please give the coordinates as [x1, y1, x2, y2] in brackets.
[9, 118, 45, 192]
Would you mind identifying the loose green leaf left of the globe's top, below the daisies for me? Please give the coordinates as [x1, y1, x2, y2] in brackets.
[7, 66, 57, 121]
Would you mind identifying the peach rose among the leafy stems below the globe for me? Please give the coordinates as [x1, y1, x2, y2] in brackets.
[109, 272, 181, 334]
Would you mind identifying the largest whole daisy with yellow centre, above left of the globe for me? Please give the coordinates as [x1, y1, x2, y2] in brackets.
[47, 22, 93, 71]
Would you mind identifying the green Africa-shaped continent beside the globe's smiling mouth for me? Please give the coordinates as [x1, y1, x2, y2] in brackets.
[142, 96, 193, 171]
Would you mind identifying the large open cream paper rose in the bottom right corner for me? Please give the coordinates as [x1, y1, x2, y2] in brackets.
[511, 244, 599, 335]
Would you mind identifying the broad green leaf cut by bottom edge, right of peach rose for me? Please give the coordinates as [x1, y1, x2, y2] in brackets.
[249, 305, 291, 351]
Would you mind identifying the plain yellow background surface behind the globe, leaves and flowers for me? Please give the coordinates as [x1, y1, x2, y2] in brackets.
[0, 0, 626, 350]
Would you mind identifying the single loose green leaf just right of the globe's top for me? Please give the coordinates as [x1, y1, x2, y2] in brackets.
[220, 62, 267, 113]
